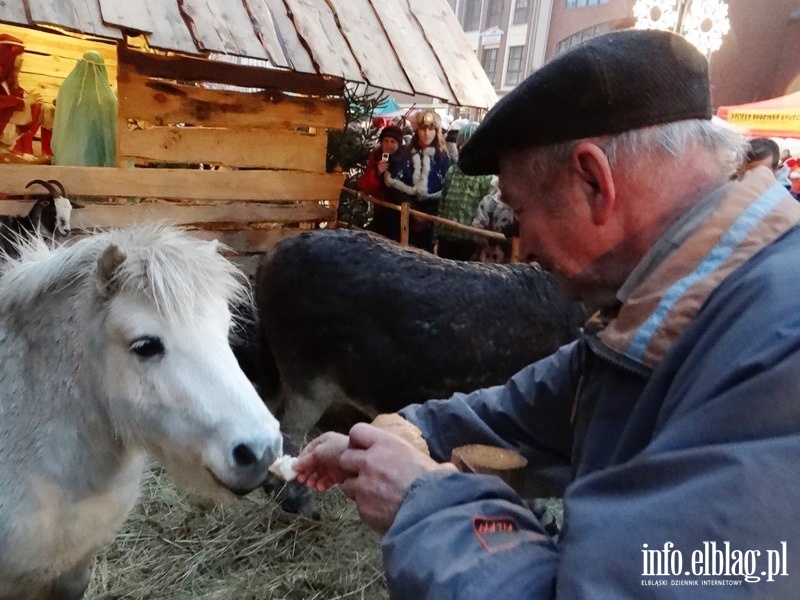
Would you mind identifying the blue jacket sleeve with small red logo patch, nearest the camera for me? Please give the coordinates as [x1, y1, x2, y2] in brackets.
[382, 473, 558, 600]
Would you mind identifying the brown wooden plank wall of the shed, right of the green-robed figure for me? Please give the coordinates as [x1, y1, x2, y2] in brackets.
[108, 48, 344, 251]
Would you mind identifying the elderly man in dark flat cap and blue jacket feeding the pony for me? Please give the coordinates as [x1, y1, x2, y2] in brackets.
[298, 30, 800, 600]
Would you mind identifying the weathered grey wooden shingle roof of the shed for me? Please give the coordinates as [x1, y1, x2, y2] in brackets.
[0, 0, 497, 108]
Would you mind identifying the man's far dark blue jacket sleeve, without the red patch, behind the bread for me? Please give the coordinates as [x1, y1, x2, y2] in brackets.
[400, 342, 583, 464]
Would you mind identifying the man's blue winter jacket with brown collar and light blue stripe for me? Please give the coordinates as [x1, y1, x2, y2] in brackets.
[390, 169, 800, 600]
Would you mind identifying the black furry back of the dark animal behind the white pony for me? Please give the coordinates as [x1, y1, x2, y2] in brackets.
[256, 230, 584, 410]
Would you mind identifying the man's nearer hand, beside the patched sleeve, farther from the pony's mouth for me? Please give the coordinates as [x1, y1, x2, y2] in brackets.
[339, 423, 456, 533]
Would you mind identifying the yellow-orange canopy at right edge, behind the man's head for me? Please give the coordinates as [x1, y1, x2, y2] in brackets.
[717, 92, 800, 138]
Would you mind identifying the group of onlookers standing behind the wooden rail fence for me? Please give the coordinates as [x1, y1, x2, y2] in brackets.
[358, 109, 513, 262]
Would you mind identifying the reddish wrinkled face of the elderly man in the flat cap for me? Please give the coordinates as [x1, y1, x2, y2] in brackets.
[500, 142, 648, 308]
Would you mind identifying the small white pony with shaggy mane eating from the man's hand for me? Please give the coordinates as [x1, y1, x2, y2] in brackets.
[0, 224, 282, 600]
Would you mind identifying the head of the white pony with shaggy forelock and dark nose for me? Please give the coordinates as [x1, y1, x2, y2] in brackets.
[95, 226, 282, 493]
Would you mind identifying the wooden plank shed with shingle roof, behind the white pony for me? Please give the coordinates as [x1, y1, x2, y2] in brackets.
[0, 0, 496, 252]
